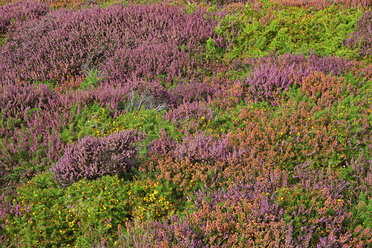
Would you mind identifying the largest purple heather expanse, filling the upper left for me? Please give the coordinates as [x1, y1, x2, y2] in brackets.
[0, 5, 223, 83]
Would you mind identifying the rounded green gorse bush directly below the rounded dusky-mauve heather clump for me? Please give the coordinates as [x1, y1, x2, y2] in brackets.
[64, 176, 132, 247]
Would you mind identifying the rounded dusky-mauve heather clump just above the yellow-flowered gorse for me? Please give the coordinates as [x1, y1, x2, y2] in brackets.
[50, 131, 141, 187]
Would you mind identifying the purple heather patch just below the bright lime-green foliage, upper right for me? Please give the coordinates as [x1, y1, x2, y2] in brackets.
[242, 54, 354, 100]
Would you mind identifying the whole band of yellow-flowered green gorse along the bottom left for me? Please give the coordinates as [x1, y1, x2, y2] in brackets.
[5, 172, 184, 247]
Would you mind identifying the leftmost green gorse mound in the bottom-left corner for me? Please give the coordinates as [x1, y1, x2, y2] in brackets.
[6, 172, 77, 247]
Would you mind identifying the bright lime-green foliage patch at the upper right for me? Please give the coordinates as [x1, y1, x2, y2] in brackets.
[216, 4, 362, 59]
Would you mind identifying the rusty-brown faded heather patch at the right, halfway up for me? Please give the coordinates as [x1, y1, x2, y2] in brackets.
[224, 97, 371, 180]
